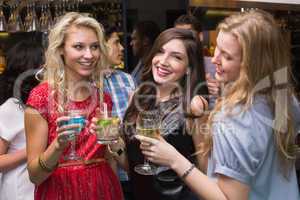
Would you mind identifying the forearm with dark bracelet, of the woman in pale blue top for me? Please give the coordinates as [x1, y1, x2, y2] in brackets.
[171, 154, 226, 200]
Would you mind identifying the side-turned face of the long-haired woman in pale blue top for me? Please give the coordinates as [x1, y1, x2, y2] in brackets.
[212, 31, 242, 84]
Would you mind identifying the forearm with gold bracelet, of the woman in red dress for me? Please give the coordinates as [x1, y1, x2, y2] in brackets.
[28, 140, 63, 185]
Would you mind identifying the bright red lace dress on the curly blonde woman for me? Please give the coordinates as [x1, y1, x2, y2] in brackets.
[27, 83, 123, 200]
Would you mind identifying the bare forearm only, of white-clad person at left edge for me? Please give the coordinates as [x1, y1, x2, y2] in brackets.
[0, 149, 26, 172]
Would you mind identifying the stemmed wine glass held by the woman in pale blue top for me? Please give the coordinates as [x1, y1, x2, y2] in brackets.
[134, 110, 161, 175]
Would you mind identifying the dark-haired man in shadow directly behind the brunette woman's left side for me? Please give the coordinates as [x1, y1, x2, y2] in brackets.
[130, 21, 160, 85]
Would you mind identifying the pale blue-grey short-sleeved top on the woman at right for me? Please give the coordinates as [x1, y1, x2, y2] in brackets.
[208, 96, 300, 200]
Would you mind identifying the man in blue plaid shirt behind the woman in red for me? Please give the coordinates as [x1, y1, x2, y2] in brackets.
[103, 26, 136, 200]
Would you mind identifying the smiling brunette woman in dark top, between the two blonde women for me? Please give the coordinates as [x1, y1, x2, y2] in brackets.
[101, 28, 208, 200]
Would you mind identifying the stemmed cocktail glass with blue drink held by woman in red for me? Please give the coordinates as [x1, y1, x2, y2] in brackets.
[59, 109, 86, 161]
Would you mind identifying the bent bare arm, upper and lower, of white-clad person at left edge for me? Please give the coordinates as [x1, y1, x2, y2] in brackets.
[0, 137, 26, 172]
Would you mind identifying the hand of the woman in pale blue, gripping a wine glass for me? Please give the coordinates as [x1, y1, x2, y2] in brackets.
[135, 135, 180, 167]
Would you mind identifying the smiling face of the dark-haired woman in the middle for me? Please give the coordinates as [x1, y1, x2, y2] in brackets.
[152, 39, 188, 85]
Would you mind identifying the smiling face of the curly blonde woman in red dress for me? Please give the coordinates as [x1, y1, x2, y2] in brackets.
[62, 26, 101, 80]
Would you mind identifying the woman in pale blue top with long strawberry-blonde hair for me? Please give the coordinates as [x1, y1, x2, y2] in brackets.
[137, 10, 300, 200]
